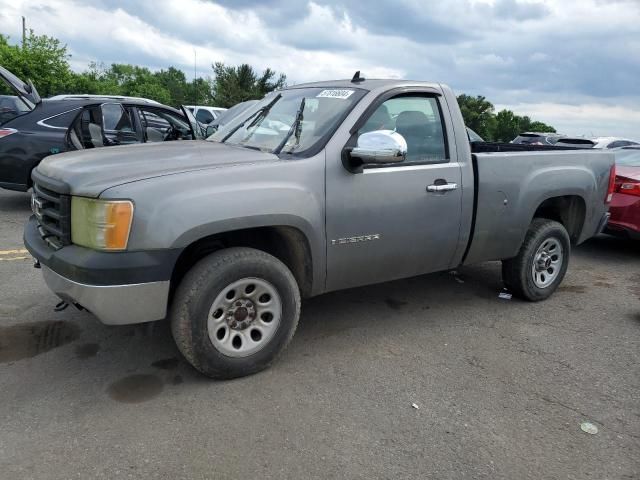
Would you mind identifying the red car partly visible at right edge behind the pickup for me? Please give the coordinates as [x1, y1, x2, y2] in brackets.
[606, 147, 640, 240]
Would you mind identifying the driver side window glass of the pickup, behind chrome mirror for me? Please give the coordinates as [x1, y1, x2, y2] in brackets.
[358, 95, 449, 163]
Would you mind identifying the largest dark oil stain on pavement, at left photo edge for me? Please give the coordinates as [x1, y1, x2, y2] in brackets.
[0, 321, 81, 363]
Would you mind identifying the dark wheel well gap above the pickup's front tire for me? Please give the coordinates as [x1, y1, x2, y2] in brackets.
[170, 226, 313, 298]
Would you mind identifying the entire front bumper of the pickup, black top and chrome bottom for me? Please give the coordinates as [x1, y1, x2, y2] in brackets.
[24, 217, 181, 325]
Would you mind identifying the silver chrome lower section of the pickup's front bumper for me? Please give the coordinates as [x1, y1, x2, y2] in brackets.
[42, 265, 169, 325]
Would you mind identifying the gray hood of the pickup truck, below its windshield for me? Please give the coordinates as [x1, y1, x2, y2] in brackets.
[37, 140, 278, 197]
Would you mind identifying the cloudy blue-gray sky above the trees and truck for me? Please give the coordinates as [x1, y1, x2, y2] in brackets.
[0, 0, 640, 139]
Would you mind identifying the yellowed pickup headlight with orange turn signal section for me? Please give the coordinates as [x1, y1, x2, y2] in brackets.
[71, 197, 133, 250]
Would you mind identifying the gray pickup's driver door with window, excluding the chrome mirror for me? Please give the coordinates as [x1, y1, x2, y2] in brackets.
[326, 93, 462, 290]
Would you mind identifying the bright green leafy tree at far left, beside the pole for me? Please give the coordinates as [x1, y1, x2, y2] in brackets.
[0, 30, 73, 97]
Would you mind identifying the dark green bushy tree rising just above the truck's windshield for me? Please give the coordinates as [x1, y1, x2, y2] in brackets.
[212, 62, 286, 107]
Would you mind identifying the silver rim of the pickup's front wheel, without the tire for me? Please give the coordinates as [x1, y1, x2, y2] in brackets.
[207, 278, 282, 357]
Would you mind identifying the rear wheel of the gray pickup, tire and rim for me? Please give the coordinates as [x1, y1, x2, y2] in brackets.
[502, 218, 571, 302]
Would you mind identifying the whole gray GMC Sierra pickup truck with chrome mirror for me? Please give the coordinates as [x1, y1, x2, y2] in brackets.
[24, 77, 613, 378]
